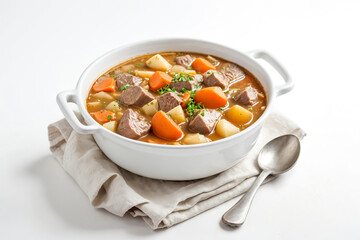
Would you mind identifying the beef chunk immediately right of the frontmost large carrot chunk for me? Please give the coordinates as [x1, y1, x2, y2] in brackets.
[188, 109, 221, 135]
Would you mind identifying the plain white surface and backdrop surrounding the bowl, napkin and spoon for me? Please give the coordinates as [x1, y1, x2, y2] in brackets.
[0, 1, 360, 239]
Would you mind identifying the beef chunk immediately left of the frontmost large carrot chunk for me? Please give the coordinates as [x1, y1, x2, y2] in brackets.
[117, 109, 151, 139]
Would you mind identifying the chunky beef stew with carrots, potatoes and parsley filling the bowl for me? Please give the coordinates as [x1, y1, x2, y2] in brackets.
[86, 52, 267, 145]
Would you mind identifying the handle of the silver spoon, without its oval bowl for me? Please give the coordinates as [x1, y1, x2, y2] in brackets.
[222, 171, 270, 227]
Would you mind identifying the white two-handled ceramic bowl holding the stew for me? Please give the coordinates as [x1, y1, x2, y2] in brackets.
[57, 39, 293, 180]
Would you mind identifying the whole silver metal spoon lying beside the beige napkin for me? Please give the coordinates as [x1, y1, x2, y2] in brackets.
[222, 134, 300, 227]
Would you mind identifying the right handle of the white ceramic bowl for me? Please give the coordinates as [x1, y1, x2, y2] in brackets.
[248, 50, 294, 96]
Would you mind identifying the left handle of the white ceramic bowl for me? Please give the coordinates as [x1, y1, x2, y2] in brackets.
[56, 91, 99, 134]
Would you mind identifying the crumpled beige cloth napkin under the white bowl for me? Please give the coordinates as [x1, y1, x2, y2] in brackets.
[48, 112, 306, 229]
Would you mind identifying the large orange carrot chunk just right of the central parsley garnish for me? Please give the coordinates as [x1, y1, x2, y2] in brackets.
[194, 87, 227, 109]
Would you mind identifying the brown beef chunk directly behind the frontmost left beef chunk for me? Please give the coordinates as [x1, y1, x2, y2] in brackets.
[119, 86, 154, 108]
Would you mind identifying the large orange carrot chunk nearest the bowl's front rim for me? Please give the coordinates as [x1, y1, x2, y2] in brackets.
[151, 111, 183, 141]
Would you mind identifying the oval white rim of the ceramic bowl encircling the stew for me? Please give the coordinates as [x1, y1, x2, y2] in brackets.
[75, 38, 276, 149]
